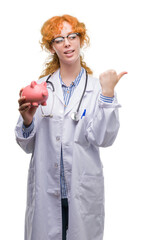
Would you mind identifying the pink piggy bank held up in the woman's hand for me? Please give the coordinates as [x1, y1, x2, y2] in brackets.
[22, 81, 48, 107]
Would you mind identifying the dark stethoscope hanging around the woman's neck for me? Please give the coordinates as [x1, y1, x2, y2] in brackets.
[41, 70, 88, 121]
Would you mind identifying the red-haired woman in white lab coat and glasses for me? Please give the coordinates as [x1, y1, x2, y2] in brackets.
[16, 15, 126, 240]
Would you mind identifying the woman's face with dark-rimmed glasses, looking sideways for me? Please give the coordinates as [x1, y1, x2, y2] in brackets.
[51, 22, 80, 64]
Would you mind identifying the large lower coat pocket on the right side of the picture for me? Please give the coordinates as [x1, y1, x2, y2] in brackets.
[79, 174, 104, 216]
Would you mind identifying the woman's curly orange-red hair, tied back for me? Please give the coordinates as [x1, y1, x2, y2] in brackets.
[39, 15, 93, 78]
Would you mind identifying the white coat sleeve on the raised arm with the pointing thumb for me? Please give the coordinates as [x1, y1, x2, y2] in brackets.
[86, 94, 120, 147]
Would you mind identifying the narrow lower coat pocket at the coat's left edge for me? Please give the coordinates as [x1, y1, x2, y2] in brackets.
[27, 168, 35, 206]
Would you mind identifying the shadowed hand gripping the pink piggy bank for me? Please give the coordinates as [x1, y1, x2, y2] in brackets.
[18, 88, 37, 126]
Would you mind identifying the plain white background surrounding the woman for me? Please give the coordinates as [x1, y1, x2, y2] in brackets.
[0, 0, 142, 240]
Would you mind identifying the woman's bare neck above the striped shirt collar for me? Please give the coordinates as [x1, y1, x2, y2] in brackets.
[60, 60, 81, 86]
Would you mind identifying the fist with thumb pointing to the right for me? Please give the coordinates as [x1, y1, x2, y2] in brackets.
[99, 70, 127, 97]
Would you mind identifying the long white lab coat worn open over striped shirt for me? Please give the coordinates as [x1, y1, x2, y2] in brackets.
[16, 70, 119, 240]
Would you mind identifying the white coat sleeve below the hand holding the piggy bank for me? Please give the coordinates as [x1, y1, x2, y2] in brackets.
[15, 116, 36, 153]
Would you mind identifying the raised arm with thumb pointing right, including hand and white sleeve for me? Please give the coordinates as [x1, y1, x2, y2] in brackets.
[86, 70, 126, 147]
